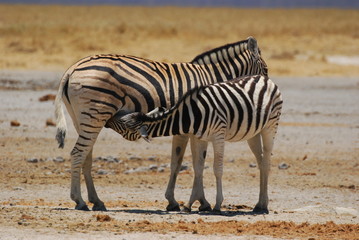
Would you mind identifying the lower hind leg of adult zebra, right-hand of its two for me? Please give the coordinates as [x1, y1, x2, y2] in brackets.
[82, 149, 107, 211]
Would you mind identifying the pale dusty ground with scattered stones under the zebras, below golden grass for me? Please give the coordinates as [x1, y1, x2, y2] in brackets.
[0, 71, 359, 239]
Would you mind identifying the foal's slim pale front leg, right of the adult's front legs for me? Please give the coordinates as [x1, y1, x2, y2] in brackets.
[213, 137, 224, 212]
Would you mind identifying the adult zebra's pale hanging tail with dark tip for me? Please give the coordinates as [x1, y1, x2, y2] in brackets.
[55, 74, 70, 148]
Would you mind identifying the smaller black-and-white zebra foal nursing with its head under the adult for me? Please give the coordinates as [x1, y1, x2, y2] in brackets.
[107, 75, 282, 213]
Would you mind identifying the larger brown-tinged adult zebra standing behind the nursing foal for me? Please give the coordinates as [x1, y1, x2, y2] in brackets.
[55, 37, 267, 210]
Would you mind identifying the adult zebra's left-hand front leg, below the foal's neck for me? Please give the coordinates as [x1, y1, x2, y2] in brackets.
[165, 136, 189, 211]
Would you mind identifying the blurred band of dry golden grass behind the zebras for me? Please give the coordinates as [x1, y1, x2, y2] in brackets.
[0, 4, 359, 76]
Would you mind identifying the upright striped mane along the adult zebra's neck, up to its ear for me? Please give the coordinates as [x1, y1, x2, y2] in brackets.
[191, 37, 260, 64]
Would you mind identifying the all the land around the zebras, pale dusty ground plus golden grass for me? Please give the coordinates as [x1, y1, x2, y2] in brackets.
[0, 5, 359, 239]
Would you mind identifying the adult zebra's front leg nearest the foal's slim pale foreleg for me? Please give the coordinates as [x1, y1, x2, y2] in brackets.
[184, 137, 212, 212]
